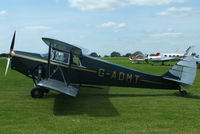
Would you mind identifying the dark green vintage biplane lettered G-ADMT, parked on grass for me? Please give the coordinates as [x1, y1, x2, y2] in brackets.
[5, 33, 196, 98]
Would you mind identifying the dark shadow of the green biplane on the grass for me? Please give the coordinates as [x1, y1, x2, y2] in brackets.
[53, 87, 200, 117]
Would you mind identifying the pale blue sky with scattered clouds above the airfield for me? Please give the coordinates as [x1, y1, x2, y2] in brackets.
[0, 0, 200, 56]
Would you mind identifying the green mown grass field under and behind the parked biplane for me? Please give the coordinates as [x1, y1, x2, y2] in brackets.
[0, 58, 200, 134]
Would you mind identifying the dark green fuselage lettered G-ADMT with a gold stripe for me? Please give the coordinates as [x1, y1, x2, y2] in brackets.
[11, 51, 180, 90]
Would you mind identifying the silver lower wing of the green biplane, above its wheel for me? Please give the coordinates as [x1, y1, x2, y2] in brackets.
[37, 79, 79, 96]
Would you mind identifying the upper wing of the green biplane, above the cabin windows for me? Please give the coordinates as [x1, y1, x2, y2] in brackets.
[42, 38, 82, 56]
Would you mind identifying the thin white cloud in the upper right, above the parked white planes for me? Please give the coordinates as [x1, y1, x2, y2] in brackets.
[157, 7, 193, 16]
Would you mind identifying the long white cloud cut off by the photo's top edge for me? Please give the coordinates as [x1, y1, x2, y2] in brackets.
[68, 0, 185, 10]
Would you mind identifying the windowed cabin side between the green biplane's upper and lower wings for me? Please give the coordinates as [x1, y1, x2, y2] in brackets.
[48, 49, 84, 85]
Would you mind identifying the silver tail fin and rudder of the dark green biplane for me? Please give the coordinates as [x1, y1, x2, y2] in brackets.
[163, 56, 197, 88]
